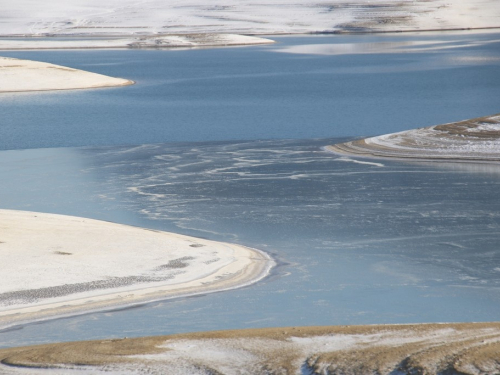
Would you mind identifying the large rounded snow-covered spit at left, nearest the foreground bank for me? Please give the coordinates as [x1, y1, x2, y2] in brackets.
[0, 210, 273, 326]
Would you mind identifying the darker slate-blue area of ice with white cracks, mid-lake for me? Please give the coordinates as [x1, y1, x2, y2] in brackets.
[79, 140, 500, 290]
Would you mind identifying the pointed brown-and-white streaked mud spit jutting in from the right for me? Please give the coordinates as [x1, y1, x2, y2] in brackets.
[326, 114, 500, 162]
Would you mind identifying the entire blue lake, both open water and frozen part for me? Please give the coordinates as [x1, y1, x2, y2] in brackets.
[0, 34, 500, 346]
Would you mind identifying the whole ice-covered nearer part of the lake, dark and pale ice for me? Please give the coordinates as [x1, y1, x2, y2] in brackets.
[0, 139, 500, 345]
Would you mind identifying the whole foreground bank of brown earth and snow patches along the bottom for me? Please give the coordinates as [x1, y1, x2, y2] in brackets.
[0, 323, 500, 374]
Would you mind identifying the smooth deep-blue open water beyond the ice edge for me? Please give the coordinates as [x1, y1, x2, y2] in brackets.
[0, 33, 500, 149]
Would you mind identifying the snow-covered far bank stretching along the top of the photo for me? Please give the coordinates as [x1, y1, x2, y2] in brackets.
[0, 0, 500, 36]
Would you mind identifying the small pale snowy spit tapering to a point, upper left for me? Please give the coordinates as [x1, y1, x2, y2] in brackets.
[0, 57, 133, 93]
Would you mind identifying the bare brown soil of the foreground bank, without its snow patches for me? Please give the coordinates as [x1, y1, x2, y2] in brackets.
[0, 323, 500, 374]
